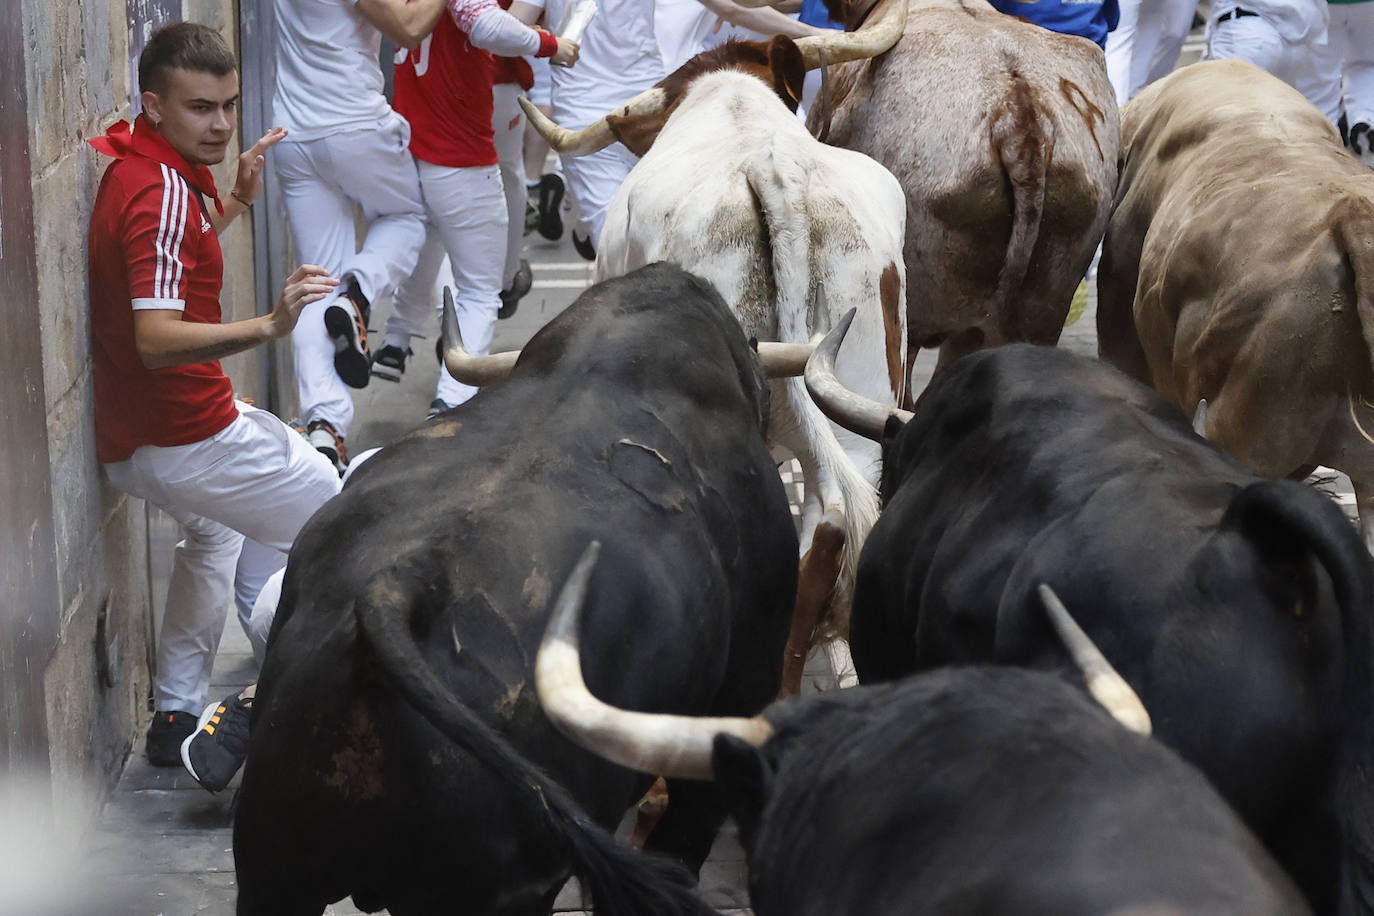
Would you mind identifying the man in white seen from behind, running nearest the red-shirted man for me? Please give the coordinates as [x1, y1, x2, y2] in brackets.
[272, 0, 444, 472]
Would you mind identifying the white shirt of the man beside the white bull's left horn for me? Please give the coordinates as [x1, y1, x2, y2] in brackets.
[519, 0, 668, 129]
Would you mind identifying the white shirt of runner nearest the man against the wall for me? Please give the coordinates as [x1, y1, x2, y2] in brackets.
[272, 0, 394, 141]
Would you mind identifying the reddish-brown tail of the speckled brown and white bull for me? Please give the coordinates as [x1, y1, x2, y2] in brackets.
[989, 70, 1054, 343]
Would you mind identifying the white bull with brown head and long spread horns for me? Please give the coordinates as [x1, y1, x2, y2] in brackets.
[526, 1, 908, 694]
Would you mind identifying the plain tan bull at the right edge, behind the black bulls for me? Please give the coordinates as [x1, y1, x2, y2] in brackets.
[1098, 60, 1374, 547]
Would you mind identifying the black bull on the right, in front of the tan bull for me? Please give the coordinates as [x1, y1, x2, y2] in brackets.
[851, 345, 1374, 913]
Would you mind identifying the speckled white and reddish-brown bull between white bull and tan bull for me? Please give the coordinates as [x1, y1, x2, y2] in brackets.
[809, 0, 1118, 390]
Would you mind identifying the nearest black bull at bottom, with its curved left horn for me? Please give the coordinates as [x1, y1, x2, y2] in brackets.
[536, 554, 1308, 916]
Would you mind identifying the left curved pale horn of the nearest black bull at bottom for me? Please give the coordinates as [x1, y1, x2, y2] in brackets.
[534, 541, 772, 779]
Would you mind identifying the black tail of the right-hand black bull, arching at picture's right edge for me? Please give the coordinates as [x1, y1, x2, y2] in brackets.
[1223, 481, 1374, 913]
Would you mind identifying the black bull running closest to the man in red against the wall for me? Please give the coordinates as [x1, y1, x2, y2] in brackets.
[234, 265, 797, 916]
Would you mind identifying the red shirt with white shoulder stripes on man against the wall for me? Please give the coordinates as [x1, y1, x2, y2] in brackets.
[89, 115, 238, 461]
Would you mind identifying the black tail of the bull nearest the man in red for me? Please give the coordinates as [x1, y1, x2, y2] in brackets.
[356, 571, 714, 916]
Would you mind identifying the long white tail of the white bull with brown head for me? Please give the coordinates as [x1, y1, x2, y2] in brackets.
[746, 135, 878, 641]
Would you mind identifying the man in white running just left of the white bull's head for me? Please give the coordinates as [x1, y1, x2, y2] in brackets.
[511, 0, 666, 252]
